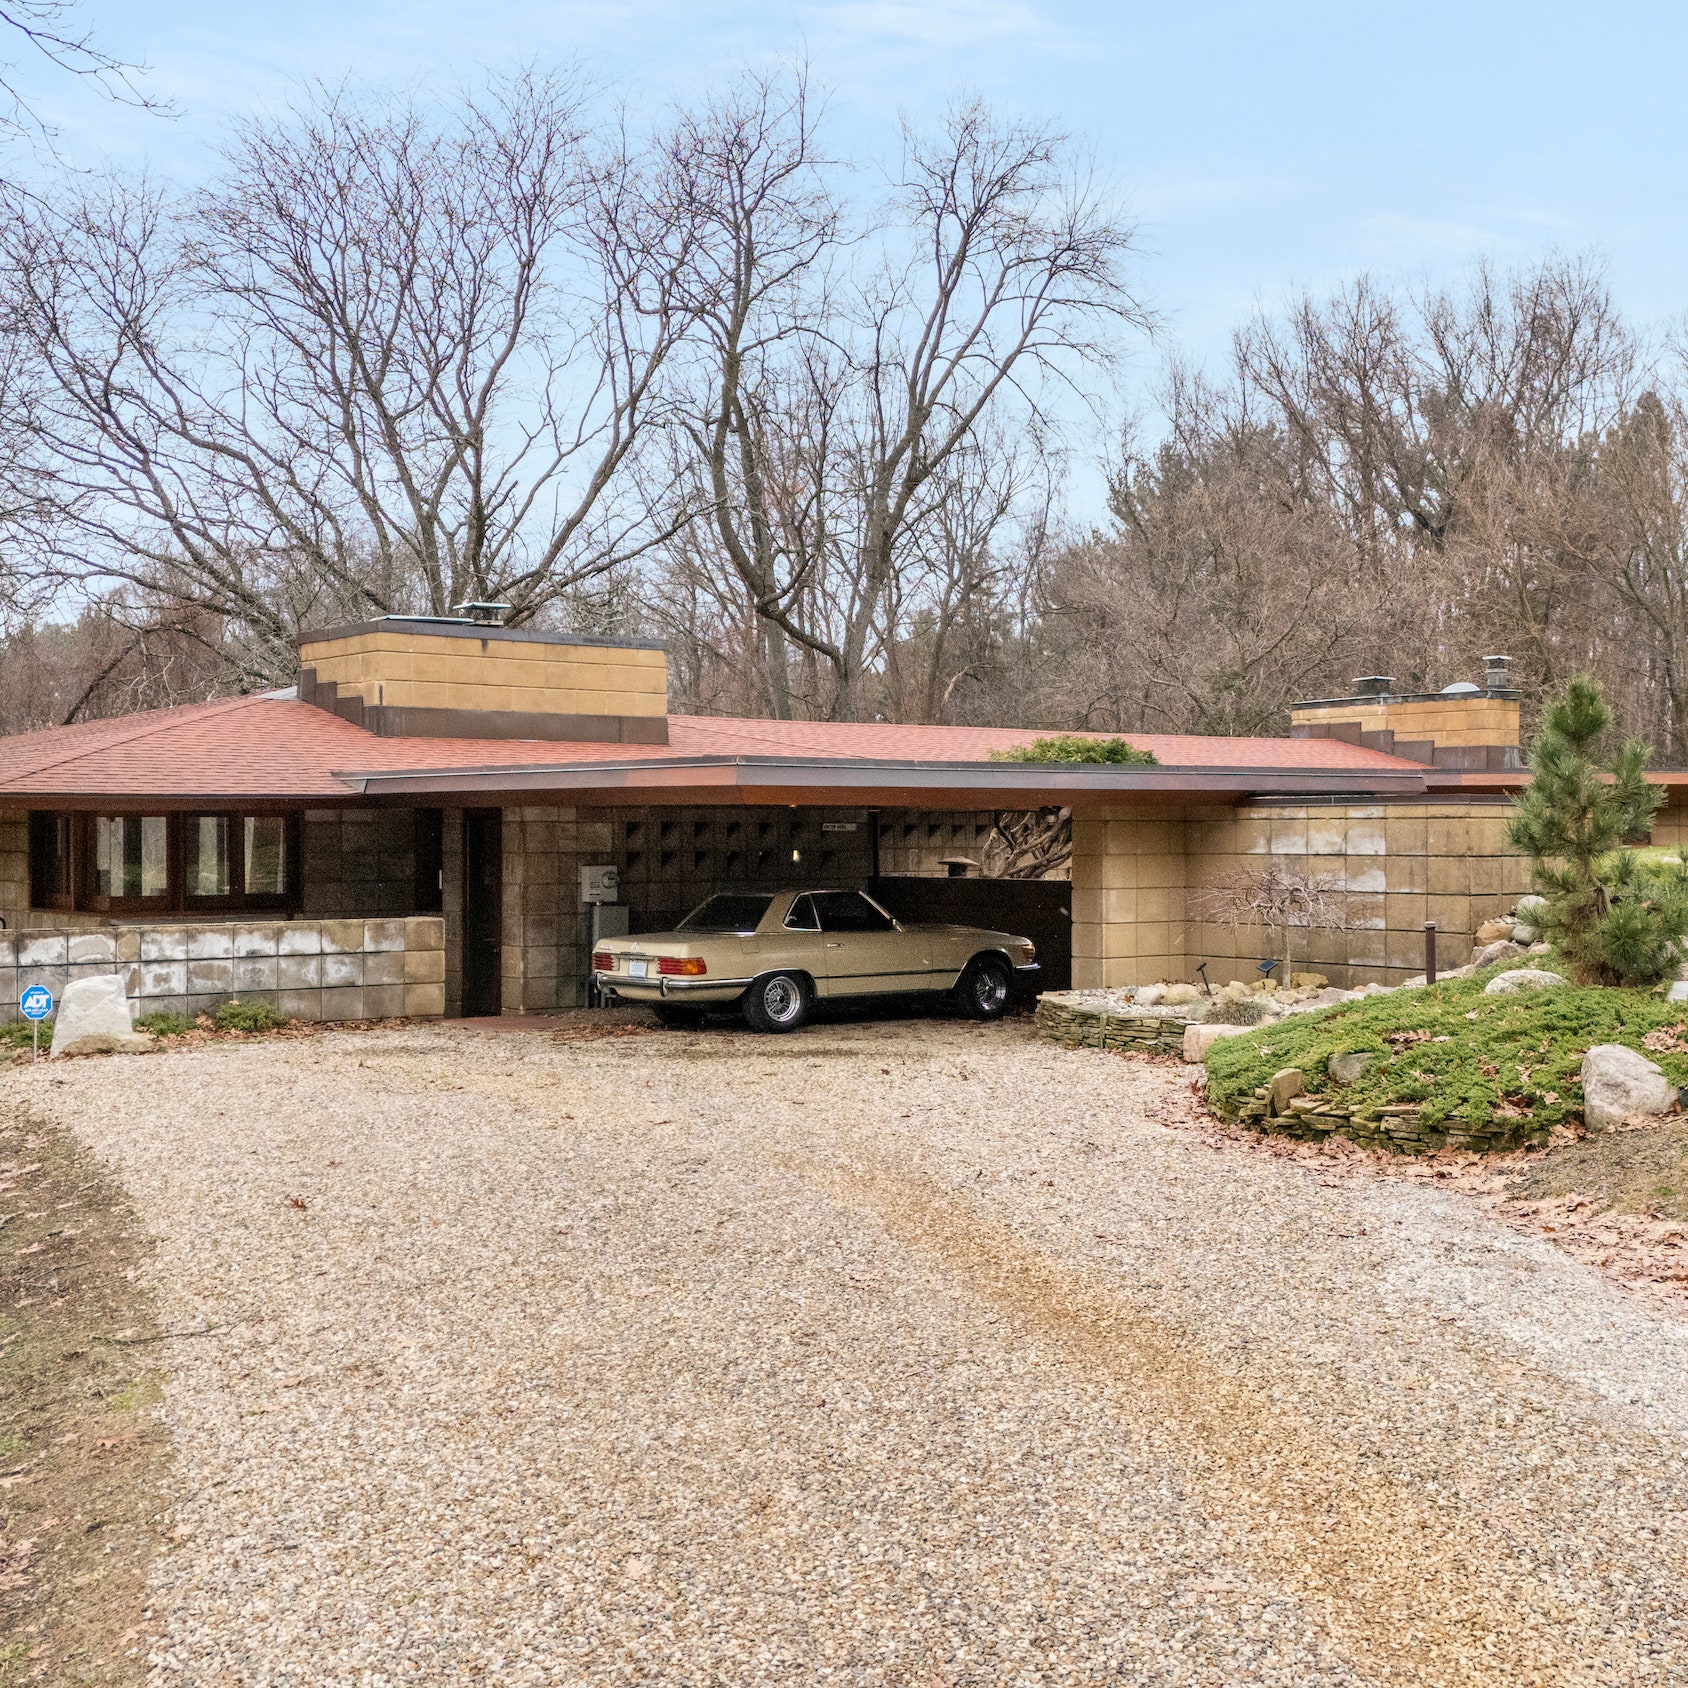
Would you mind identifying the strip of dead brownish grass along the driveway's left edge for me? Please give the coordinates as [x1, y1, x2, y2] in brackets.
[0, 1093, 170, 1688]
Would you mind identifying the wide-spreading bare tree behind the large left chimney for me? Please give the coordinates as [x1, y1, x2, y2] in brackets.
[7, 76, 694, 680]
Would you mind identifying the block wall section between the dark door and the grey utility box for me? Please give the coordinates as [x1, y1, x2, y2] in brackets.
[496, 805, 611, 1014]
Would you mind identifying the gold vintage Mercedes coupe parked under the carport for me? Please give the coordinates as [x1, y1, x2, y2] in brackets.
[592, 891, 1038, 1031]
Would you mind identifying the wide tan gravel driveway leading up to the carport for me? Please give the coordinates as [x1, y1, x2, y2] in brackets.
[0, 1021, 1688, 1688]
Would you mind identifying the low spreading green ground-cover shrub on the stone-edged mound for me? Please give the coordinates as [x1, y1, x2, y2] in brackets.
[1207, 957, 1688, 1138]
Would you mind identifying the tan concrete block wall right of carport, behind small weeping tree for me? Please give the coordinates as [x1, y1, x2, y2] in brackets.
[1072, 798, 1531, 989]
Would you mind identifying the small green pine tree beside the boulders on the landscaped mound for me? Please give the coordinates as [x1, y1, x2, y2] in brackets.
[1507, 680, 1688, 986]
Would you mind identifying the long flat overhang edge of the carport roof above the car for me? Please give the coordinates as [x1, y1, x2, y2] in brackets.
[336, 756, 1425, 809]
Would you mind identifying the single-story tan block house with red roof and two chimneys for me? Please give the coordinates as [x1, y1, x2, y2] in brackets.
[0, 616, 1688, 1020]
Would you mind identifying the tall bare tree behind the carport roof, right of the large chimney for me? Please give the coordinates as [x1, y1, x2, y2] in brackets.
[658, 83, 1144, 719]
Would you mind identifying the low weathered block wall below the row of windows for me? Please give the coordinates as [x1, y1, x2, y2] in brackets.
[0, 915, 446, 1023]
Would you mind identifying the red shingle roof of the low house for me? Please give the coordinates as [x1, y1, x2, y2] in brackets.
[0, 697, 1438, 800]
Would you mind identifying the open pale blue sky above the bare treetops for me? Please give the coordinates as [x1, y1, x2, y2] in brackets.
[20, 0, 1688, 496]
